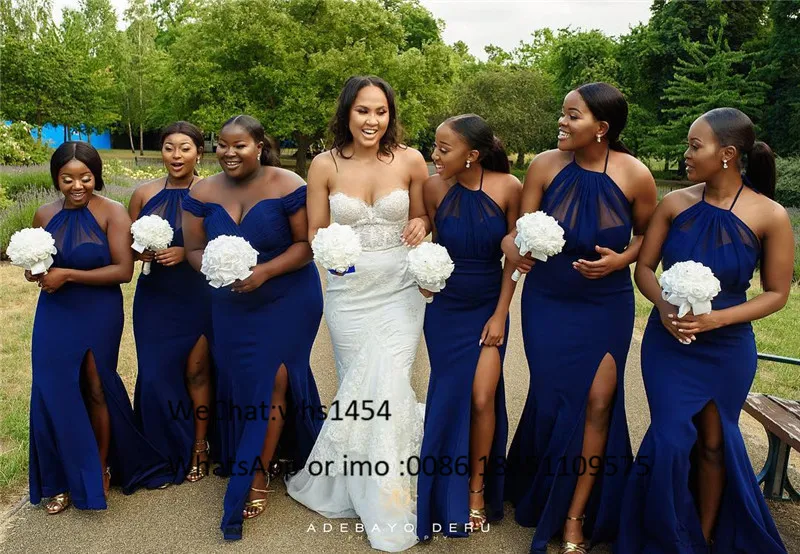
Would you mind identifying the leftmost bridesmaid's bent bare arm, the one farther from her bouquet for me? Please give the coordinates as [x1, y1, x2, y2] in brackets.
[41, 200, 133, 292]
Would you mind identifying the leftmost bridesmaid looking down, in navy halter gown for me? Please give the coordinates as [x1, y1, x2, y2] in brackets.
[25, 142, 167, 514]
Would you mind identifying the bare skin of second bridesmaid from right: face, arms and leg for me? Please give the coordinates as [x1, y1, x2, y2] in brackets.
[503, 91, 657, 543]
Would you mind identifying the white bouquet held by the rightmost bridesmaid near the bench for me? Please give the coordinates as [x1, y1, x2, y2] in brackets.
[658, 260, 721, 317]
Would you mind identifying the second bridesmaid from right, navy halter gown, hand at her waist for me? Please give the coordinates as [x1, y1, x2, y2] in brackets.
[503, 83, 656, 552]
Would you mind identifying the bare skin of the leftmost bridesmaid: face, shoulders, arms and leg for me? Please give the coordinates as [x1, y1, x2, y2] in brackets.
[25, 160, 133, 506]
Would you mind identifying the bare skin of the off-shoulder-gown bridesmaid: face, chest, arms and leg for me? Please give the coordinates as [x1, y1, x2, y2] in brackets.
[183, 124, 312, 516]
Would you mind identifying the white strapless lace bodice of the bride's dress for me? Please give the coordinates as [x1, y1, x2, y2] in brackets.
[329, 189, 409, 251]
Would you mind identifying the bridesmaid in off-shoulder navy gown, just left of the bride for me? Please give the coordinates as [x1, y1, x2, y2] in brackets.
[183, 115, 322, 539]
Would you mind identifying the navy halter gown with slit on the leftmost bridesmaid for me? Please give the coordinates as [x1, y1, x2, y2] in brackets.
[28, 201, 168, 510]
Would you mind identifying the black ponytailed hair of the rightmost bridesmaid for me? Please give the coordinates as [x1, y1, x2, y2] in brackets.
[700, 108, 775, 199]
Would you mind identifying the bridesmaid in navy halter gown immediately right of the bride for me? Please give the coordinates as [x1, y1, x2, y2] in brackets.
[417, 114, 522, 540]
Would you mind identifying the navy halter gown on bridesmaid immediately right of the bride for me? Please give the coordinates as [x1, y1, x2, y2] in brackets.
[417, 179, 508, 540]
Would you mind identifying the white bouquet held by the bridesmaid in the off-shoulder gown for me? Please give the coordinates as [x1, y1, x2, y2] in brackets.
[200, 235, 258, 289]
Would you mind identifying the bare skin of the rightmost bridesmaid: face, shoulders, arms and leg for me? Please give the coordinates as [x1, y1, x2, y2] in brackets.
[635, 118, 794, 540]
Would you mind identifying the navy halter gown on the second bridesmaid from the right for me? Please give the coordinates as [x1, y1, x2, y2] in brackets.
[505, 153, 634, 552]
